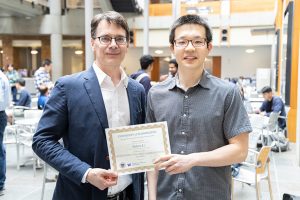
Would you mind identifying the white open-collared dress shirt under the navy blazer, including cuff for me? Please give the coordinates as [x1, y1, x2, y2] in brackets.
[82, 63, 132, 195]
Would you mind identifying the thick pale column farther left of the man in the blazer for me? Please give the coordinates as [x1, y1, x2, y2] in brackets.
[49, 1, 63, 82]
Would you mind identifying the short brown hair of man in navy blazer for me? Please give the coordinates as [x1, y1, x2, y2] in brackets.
[91, 11, 129, 41]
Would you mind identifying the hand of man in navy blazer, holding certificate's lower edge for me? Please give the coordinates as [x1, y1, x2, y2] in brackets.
[86, 168, 118, 190]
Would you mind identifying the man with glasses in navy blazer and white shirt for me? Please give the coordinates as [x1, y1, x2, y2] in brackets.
[32, 11, 145, 200]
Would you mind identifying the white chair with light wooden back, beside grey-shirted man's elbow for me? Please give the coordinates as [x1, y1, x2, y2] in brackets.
[232, 146, 273, 200]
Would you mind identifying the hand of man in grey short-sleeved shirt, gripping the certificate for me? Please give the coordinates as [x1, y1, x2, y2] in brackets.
[154, 154, 193, 175]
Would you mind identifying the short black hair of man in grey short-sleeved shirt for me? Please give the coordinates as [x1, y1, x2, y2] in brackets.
[169, 15, 212, 47]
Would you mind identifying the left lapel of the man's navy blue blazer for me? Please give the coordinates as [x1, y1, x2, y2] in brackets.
[84, 67, 108, 129]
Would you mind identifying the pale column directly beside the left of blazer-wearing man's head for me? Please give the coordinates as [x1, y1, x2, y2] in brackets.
[84, 0, 94, 69]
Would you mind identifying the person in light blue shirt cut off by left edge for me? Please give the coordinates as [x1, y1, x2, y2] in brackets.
[0, 70, 10, 196]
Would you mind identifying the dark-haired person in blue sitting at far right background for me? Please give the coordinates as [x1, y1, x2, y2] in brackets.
[256, 86, 286, 130]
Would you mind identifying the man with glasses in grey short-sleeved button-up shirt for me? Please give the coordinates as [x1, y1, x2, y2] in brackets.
[146, 15, 251, 200]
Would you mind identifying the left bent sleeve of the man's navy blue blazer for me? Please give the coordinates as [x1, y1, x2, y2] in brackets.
[32, 80, 91, 185]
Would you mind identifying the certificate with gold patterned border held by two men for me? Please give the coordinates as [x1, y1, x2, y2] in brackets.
[105, 122, 171, 175]
